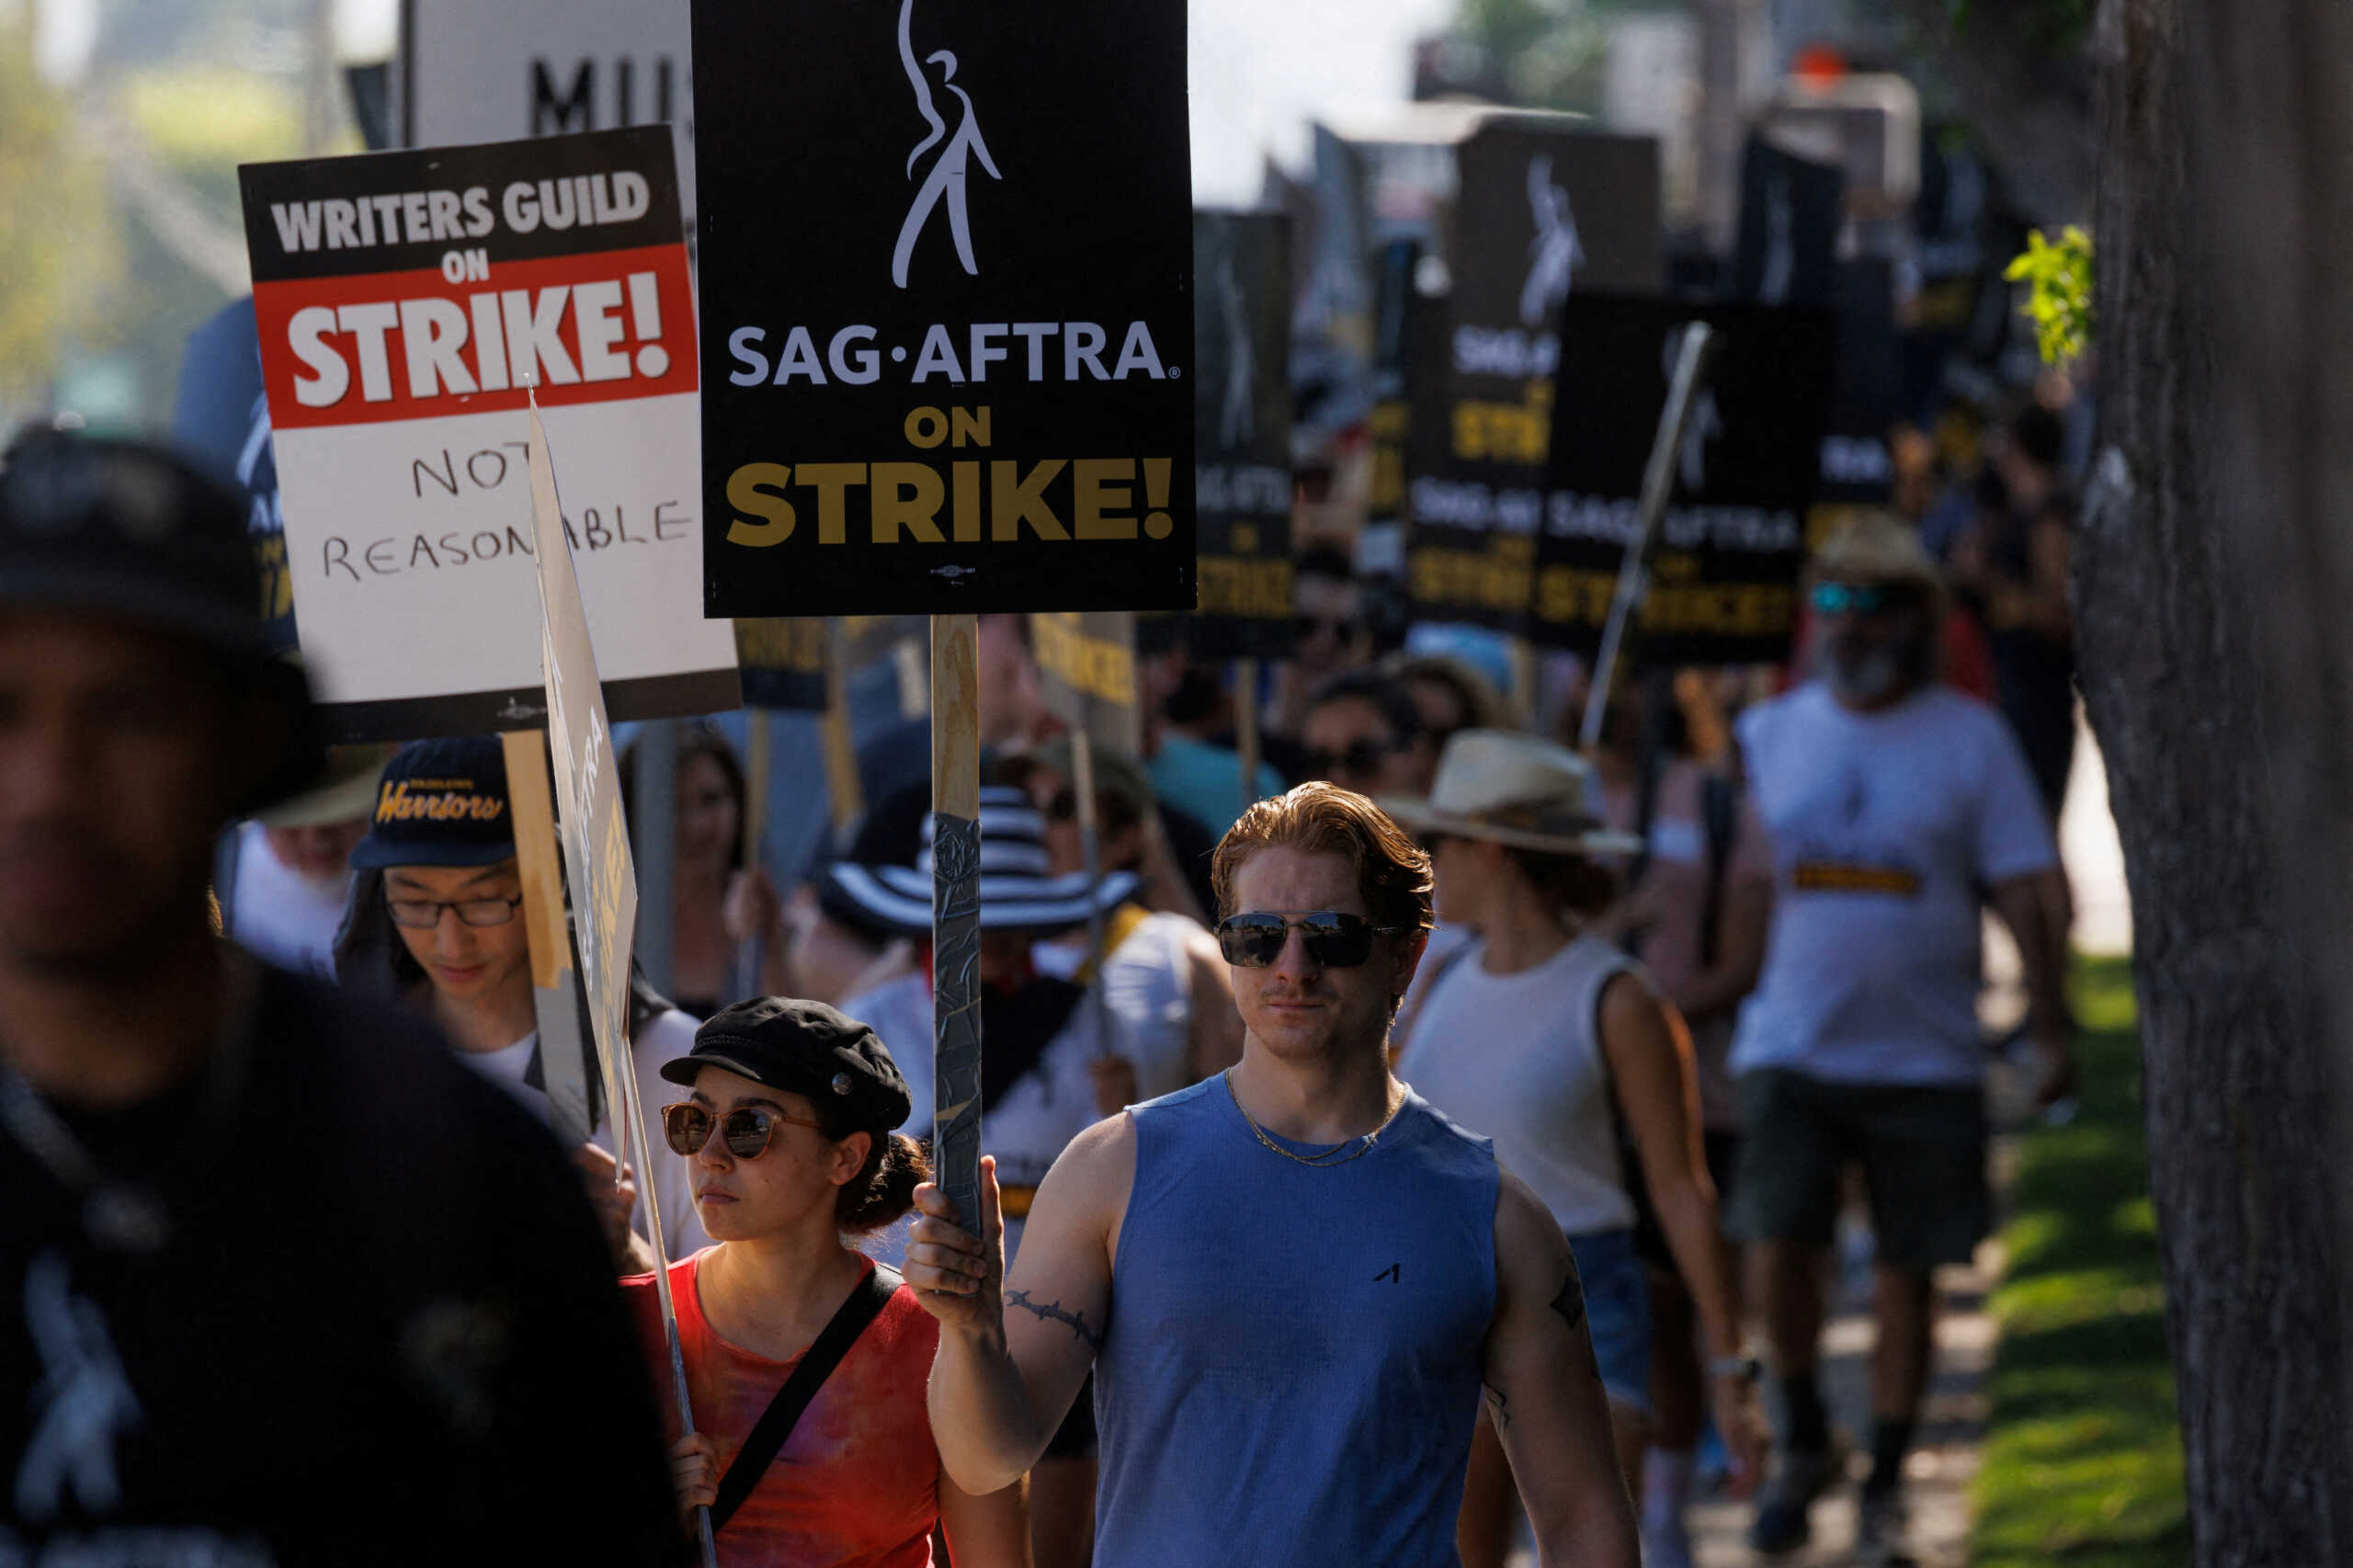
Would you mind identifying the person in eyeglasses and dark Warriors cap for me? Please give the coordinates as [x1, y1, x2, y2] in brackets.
[336, 734, 703, 1269]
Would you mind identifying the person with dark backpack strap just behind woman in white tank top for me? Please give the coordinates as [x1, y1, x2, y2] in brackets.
[1593, 671, 1772, 1568]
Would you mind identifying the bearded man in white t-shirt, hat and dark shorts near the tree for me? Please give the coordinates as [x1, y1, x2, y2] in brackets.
[1732, 516, 2073, 1563]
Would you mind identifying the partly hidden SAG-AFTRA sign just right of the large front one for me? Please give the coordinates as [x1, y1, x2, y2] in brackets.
[1186, 212, 1291, 659]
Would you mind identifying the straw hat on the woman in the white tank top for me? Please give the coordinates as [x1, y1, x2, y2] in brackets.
[1379, 730, 1643, 855]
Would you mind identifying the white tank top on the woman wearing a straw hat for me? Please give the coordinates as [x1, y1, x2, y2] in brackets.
[1398, 937, 1638, 1236]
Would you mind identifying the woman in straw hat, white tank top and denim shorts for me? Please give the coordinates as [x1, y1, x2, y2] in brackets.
[1383, 730, 1762, 1568]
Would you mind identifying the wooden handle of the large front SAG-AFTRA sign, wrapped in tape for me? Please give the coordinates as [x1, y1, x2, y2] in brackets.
[932, 615, 982, 1232]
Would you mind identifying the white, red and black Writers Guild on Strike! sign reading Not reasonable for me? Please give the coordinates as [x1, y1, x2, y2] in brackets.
[240, 127, 734, 737]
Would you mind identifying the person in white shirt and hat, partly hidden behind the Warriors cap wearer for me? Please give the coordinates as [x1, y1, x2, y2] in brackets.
[211, 746, 393, 980]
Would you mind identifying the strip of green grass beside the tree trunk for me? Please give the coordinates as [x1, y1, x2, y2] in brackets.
[1972, 959, 2188, 1568]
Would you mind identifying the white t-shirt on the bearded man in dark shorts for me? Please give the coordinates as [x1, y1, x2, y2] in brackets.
[1732, 683, 2059, 1087]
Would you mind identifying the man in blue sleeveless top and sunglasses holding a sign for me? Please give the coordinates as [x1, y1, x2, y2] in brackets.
[906, 784, 1638, 1568]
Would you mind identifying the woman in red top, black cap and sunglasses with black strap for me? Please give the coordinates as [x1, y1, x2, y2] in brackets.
[623, 996, 1029, 1568]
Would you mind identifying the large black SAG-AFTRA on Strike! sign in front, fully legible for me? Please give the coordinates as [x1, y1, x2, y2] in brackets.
[694, 0, 1195, 617]
